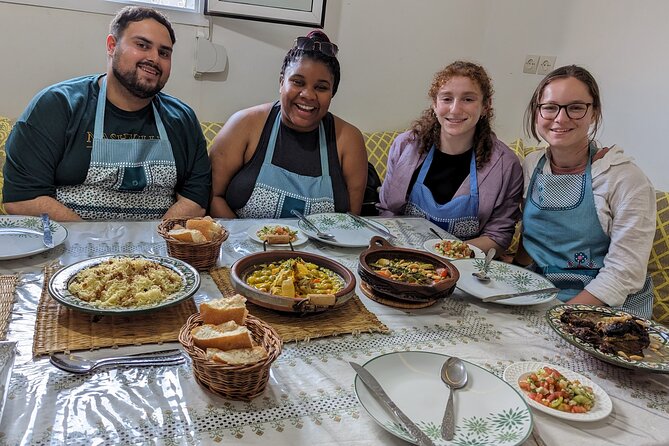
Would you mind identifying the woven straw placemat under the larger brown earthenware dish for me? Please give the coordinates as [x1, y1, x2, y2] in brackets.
[209, 268, 390, 342]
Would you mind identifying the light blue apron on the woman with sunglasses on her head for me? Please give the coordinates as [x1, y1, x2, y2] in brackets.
[235, 113, 335, 218]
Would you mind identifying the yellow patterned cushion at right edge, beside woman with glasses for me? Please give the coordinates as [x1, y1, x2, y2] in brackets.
[648, 191, 669, 325]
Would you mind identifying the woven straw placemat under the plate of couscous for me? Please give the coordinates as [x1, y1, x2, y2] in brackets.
[33, 268, 197, 356]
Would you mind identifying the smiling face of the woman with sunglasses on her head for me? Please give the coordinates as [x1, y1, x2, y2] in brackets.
[279, 58, 334, 132]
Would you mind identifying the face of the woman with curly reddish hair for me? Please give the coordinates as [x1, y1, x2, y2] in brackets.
[432, 76, 487, 149]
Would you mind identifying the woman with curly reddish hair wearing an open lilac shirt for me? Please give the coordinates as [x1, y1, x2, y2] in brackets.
[378, 61, 523, 254]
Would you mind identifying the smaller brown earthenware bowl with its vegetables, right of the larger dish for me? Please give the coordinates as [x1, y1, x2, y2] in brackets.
[358, 236, 460, 302]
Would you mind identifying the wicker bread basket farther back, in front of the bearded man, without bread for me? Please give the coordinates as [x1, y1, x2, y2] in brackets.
[158, 218, 228, 270]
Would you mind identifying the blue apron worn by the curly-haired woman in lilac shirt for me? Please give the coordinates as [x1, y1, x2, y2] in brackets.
[404, 146, 479, 240]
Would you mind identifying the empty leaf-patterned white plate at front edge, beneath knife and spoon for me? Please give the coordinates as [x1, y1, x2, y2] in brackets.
[354, 352, 532, 446]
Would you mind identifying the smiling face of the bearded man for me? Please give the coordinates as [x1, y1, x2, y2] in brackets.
[107, 19, 172, 99]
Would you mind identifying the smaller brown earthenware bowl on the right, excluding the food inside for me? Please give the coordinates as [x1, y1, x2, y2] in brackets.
[358, 236, 460, 302]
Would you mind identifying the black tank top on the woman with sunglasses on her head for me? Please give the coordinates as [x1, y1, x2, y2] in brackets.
[225, 102, 350, 212]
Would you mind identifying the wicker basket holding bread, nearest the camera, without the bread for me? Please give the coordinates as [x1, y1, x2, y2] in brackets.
[179, 313, 282, 401]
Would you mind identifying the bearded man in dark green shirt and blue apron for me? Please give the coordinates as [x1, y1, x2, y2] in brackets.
[3, 6, 211, 221]
